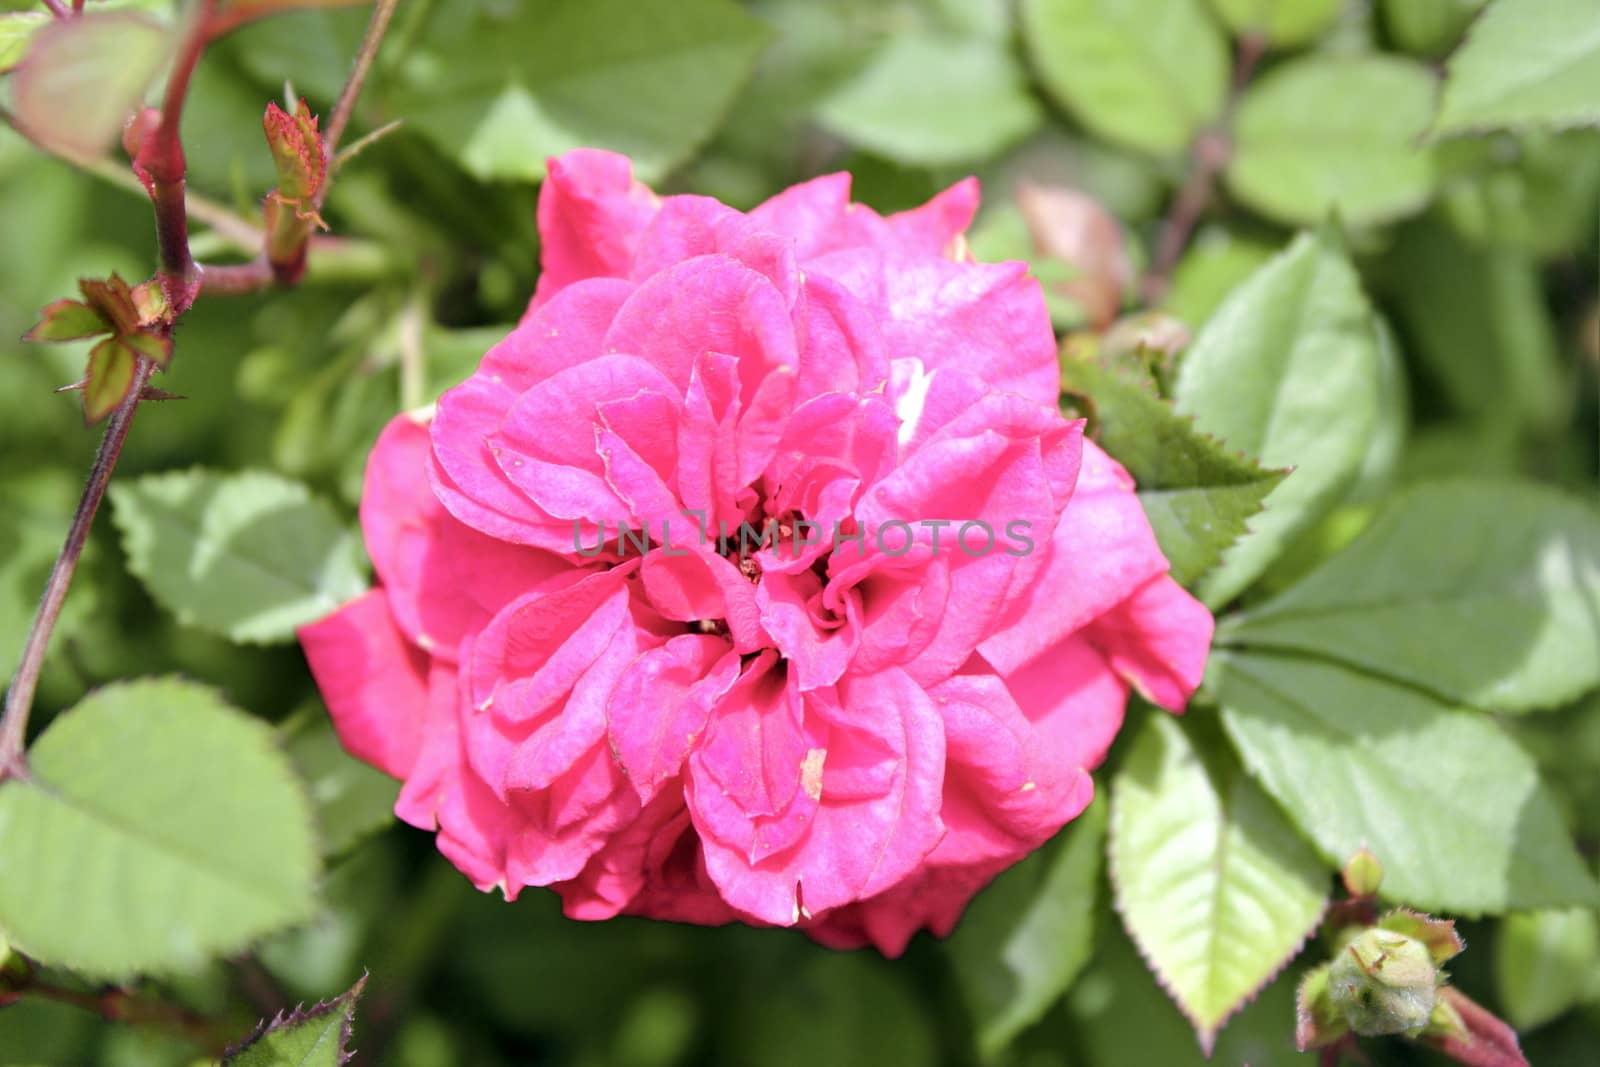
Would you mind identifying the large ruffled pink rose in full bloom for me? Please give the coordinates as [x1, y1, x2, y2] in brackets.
[301, 150, 1213, 955]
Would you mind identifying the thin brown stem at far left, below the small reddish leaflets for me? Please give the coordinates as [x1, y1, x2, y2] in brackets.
[0, 357, 155, 782]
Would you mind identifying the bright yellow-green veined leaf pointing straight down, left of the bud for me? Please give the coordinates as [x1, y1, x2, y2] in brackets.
[1109, 713, 1330, 1054]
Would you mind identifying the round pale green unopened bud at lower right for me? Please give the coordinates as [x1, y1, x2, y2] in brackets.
[1328, 926, 1438, 1037]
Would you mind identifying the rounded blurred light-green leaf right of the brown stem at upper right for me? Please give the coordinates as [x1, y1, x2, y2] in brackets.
[1226, 54, 1434, 226]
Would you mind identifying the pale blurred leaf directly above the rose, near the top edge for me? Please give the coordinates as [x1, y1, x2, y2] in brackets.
[818, 30, 1043, 165]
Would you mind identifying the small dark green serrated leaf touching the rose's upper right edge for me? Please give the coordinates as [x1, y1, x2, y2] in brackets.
[1061, 351, 1286, 585]
